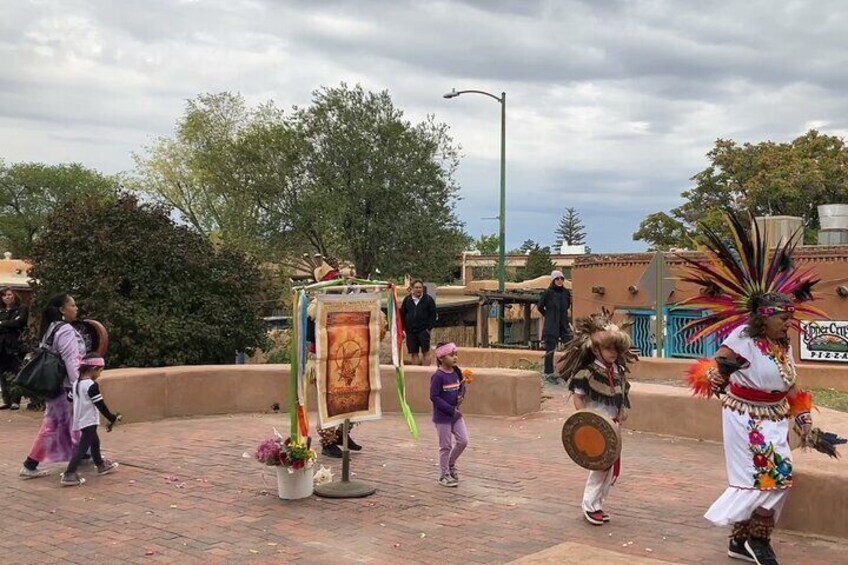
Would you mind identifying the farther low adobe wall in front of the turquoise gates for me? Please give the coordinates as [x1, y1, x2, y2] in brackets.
[459, 347, 848, 392]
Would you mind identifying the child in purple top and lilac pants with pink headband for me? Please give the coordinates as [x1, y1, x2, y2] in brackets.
[430, 343, 468, 487]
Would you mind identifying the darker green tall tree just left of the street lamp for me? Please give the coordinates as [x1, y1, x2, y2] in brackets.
[294, 84, 469, 280]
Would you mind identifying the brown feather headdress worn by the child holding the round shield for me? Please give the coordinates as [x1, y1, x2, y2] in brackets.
[557, 308, 636, 381]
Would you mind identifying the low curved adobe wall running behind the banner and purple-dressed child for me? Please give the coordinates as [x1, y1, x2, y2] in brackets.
[100, 365, 542, 422]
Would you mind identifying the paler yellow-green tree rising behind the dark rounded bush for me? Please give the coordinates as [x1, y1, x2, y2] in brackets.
[131, 92, 299, 258]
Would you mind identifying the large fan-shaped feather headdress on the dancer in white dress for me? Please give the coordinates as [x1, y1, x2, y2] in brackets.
[679, 210, 827, 342]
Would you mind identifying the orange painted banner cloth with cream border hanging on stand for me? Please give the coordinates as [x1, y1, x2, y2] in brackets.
[315, 294, 382, 428]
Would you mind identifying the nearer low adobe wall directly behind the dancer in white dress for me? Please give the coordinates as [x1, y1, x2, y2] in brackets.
[627, 382, 848, 538]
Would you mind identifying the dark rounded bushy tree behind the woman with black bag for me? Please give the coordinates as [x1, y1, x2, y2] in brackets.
[31, 194, 265, 367]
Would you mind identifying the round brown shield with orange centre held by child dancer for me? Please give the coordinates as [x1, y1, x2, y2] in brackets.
[562, 410, 621, 471]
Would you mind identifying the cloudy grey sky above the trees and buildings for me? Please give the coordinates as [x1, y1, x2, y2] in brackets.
[0, 0, 848, 251]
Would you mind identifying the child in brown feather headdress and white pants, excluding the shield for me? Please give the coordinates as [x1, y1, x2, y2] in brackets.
[559, 311, 635, 526]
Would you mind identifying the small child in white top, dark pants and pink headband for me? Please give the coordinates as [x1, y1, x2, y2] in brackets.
[60, 354, 121, 487]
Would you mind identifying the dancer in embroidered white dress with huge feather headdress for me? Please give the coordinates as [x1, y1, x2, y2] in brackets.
[680, 214, 833, 565]
